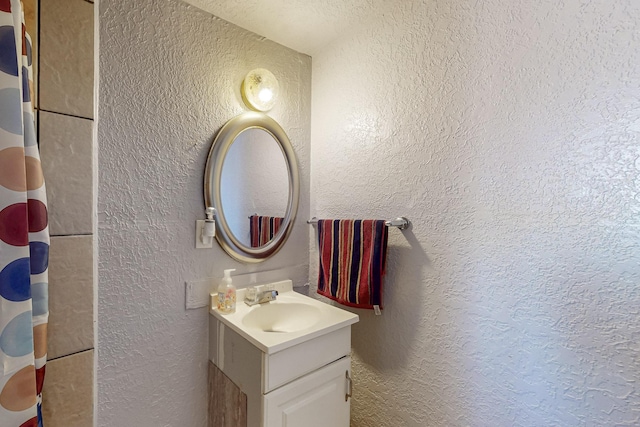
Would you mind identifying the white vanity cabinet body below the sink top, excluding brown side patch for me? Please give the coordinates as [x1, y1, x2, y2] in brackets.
[209, 316, 351, 427]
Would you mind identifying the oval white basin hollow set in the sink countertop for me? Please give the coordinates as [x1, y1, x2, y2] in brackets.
[242, 301, 321, 333]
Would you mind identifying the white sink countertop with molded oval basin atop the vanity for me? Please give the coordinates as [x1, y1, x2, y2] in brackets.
[210, 280, 358, 354]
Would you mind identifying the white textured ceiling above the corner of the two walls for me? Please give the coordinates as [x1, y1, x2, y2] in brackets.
[184, 0, 389, 55]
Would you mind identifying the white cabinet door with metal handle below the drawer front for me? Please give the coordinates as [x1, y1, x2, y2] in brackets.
[263, 357, 351, 427]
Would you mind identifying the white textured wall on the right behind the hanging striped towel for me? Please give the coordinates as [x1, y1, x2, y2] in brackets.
[311, 0, 640, 427]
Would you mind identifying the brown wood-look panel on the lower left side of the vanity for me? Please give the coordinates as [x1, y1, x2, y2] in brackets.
[209, 361, 247, 427]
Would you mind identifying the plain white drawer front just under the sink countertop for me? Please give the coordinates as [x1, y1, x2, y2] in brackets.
[262, 325, 351, 394]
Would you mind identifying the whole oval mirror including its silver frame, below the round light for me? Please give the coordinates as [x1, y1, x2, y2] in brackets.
[204, 112, 299, 262]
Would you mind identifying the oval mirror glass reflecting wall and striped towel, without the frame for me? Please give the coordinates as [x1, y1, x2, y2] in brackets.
[220, 128, 289, 248]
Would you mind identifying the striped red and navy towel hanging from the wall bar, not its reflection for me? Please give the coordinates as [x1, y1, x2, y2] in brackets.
[318, 219, 388, 309]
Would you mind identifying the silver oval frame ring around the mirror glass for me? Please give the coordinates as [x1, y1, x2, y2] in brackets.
[204, 111, 300, 263]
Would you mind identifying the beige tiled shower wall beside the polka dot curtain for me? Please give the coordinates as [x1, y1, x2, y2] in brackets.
[24, 0, 95, 427]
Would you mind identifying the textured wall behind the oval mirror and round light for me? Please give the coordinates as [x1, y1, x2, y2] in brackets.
[98, 0, 311, 427]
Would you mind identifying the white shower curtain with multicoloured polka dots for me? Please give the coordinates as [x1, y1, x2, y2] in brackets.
[0, 0, 49, 427]
